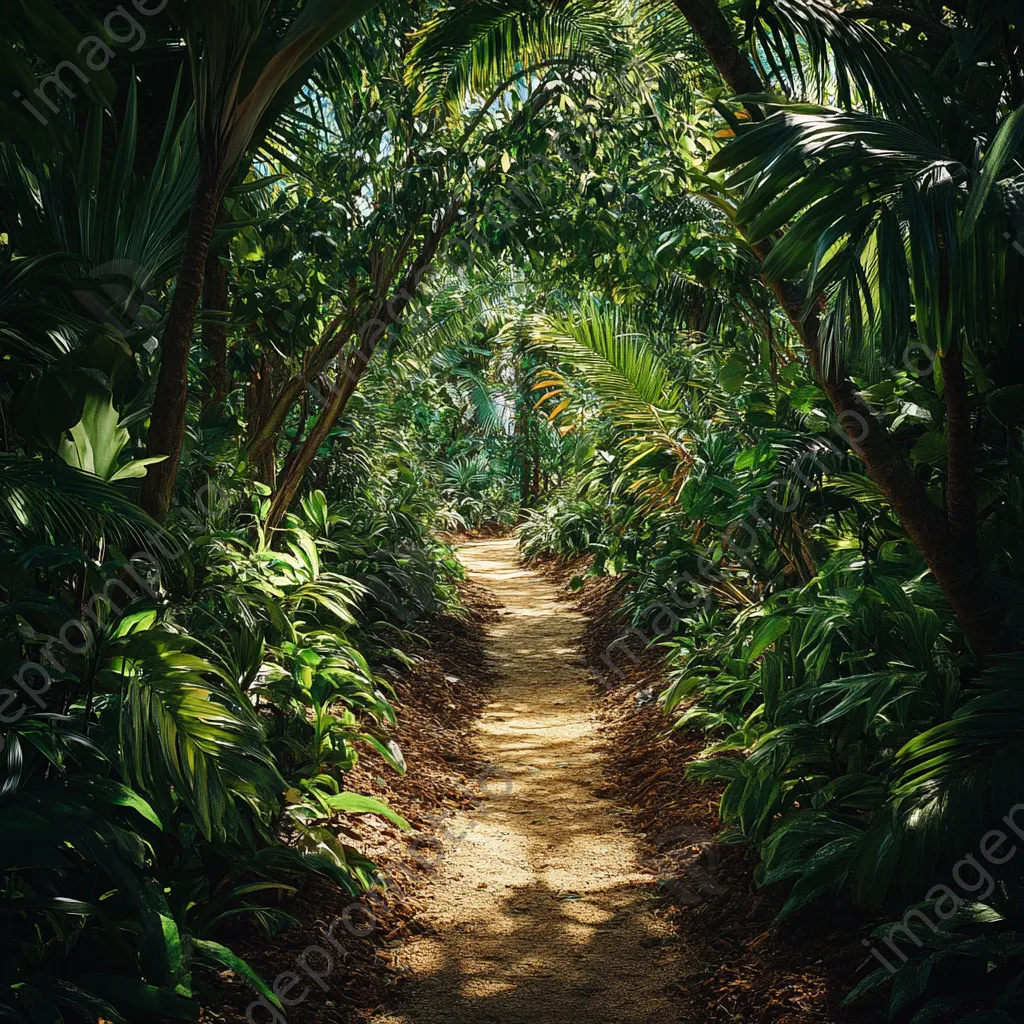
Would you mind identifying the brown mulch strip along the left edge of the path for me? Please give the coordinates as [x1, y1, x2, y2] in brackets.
[195, 583, 497, 1024]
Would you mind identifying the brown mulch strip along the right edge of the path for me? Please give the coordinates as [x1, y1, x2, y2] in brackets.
[547, 562, 885, 1024]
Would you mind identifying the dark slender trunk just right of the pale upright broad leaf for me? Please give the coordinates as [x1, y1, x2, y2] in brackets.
[139, 164, 223, 519]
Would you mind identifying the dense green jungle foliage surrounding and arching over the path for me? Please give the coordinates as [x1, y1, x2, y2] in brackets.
[0, 0, 1024, 1024]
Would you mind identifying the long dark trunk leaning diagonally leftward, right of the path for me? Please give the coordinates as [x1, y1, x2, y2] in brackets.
[675, 0, 1014, 657]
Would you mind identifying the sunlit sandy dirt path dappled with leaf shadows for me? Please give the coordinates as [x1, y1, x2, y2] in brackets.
[373, 540, 681, 1024]
